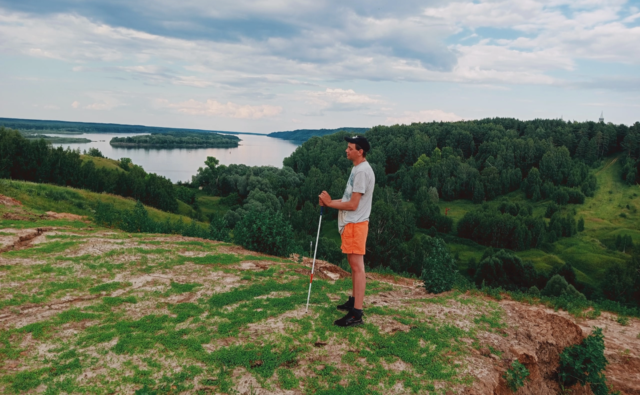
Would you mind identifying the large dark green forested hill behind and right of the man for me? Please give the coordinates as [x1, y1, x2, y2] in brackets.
[191, 118, 640, 312]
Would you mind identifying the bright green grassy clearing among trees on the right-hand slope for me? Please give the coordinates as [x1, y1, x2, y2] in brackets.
[439, 157, 640, 284]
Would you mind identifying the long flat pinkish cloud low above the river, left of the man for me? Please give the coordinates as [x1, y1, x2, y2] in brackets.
[159, 99, 282, 119]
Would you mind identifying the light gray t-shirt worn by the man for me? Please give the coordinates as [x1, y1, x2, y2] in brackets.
[338, 161, 376, 234]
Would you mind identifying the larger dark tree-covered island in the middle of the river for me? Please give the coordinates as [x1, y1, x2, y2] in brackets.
[109, 132, 240, 149]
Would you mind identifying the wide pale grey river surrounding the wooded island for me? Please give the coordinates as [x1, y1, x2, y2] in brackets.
[47, 133, 300, 182]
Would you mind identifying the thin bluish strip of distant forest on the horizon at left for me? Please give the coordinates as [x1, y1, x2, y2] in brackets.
[0, 118, 253, 134]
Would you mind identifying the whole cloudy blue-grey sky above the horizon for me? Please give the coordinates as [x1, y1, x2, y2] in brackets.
[0, 0, 640, 133]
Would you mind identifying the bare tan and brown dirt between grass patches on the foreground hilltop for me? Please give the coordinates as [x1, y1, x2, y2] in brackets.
[0, 217, 640, 395]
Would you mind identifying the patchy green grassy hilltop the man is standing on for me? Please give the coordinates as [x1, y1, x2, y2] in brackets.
[0, 196, 516, 394]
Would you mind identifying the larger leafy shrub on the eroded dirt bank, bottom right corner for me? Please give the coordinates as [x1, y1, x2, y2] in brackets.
[558, 328, 609, 395]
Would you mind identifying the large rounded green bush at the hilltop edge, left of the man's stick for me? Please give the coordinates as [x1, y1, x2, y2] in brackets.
[234, 210, 294, 257]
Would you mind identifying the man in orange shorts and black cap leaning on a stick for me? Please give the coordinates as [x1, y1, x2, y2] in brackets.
[320, 136, 376, 326]
